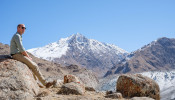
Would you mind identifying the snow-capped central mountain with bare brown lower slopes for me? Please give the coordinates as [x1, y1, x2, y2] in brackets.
[28, 33, 128, 74]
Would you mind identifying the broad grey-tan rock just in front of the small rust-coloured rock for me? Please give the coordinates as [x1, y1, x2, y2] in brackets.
[58, 82, 85, 95]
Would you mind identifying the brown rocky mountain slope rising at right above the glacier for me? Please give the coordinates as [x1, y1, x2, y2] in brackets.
[105, 37, 175, 77]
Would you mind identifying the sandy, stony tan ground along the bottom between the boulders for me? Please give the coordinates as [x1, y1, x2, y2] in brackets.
[33, 87, 154, 100]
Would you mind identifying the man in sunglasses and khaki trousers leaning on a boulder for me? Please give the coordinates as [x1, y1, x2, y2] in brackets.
[10, 24, 54, 88]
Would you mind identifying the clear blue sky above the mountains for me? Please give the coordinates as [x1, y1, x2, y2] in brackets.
[0, 0, 175, 52]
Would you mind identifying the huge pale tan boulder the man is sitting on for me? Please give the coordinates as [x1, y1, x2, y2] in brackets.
[0, 59, 39, 100]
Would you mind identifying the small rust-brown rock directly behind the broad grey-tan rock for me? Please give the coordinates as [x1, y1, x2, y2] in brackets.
[64, 75, 80, 84]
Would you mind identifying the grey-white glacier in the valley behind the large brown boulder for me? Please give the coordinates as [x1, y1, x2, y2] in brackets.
[97, 70, 175, 100]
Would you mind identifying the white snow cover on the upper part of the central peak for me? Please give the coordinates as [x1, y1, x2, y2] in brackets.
[27, 33, 127, 60]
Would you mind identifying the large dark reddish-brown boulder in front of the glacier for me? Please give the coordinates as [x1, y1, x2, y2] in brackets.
[116, 74, 160, 100]
